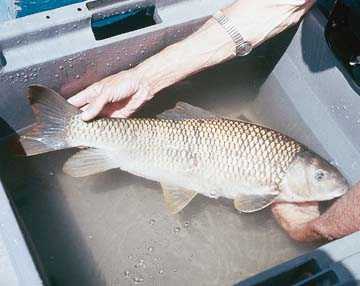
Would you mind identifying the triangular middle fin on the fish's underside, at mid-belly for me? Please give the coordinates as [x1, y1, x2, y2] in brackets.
[161, 184, 196, 214]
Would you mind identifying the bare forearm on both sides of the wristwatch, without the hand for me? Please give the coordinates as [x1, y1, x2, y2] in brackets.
[135, 0, 315, 94]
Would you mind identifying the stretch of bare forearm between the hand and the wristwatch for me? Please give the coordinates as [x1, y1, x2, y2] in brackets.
[136, 19, 235, 94]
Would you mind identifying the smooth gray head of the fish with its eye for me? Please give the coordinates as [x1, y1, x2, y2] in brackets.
[280, 151, 349, 202]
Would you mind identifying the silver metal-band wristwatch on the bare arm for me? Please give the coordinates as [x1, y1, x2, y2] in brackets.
[213, 10, 253, 56]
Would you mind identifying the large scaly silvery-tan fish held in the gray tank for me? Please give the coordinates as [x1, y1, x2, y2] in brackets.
[20, 85, 348, 214]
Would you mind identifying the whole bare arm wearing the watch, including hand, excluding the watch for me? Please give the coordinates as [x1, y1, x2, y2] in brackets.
[69, 0, 315, 120]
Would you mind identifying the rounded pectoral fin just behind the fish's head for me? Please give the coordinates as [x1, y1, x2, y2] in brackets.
[234, 188, 279, 213]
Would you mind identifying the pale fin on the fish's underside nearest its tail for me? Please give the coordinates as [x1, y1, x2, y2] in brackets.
[63, 148, 118, 177]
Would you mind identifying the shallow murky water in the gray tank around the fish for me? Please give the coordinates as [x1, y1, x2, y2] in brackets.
[1, 50, 320, 285]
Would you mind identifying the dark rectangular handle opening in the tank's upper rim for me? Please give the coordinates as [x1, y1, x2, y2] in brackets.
[91, 6, 156, 40]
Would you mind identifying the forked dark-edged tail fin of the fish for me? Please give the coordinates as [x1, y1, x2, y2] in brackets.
[19, 85, 79, 156]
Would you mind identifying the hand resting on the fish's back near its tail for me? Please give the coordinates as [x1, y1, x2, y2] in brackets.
[68, 69, 153, 121]
